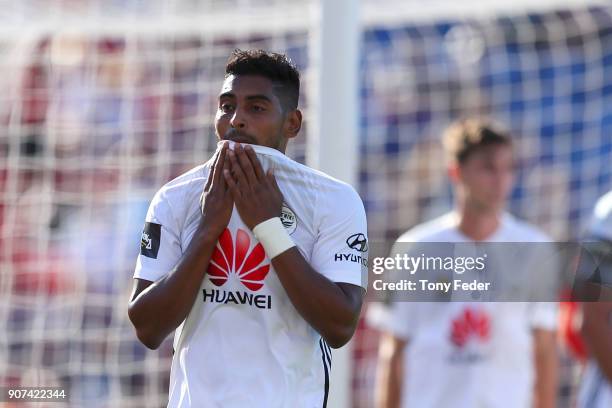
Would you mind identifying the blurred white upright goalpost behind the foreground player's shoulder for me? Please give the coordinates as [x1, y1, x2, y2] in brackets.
[306, 0, 360, 408]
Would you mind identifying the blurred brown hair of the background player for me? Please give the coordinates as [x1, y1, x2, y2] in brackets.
[442, 118, 512, 164]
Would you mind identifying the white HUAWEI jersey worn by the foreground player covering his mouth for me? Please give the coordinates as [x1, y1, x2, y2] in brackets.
[134, 142, 367, 408]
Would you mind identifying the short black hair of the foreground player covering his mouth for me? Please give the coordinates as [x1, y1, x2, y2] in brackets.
[225, 49, 300, 112]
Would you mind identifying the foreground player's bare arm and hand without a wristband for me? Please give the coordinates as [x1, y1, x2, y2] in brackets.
[128, 146, 233, 349]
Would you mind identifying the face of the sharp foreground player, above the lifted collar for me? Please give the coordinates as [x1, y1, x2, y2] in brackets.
[215, 75, 301, 152]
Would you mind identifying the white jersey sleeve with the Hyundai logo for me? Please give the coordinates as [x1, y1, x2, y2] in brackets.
[311, 185, 368, 289]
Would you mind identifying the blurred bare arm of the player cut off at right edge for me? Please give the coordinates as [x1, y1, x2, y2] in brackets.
[582, 302, 612, 383]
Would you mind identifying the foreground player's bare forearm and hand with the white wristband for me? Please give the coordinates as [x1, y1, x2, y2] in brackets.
[224, 144, 365, 348]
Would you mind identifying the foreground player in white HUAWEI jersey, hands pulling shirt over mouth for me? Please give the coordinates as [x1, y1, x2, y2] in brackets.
[129, 50, 367, 408]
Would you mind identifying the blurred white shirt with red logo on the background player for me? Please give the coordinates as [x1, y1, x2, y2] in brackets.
[383, 213, 557, 408]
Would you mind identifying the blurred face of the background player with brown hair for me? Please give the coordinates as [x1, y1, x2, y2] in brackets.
[456, 145, 514, 212]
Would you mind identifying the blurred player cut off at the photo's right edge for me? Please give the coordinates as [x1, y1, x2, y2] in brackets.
[578, 191, 612, 408]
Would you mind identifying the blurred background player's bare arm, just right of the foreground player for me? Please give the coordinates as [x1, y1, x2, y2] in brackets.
[375, 332, 407, 408]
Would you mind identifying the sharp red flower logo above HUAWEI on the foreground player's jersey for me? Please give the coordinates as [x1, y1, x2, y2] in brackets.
[208, 228, 270, 291]
